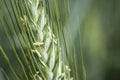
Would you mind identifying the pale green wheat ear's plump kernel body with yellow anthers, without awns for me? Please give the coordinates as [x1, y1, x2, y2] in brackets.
[25, 0, 70, 80]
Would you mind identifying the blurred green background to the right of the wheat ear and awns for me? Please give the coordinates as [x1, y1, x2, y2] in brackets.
[61, 0, 120, 80]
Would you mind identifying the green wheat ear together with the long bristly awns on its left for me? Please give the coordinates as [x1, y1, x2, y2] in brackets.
[0, 0, 72, 80]
